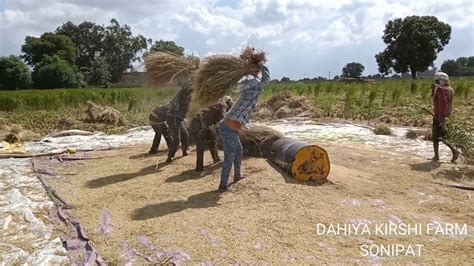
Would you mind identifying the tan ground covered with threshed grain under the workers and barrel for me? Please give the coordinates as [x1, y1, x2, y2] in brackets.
[48, 144, 474, 265]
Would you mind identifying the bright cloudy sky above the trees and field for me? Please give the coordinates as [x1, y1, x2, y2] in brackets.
[0, 0, 474, 79]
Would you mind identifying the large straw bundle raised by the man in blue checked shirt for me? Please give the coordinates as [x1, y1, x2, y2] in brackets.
[193, 47, 267, 109]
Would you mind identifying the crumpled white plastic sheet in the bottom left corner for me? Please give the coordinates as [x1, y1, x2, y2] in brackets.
[0, 159, 68, 265]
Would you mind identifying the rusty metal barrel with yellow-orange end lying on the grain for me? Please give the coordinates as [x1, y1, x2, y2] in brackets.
[268, 138, 330, 181]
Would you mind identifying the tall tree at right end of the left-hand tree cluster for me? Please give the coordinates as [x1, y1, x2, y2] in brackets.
[101, 19, 147, 82]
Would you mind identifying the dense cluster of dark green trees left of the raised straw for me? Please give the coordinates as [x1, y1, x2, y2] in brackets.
[0, 19, 184, 90]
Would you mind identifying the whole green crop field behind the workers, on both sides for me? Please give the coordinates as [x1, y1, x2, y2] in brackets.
[0, 78, 474, 133]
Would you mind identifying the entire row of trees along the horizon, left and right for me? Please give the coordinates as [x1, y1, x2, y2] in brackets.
[0, 16, 474, 89]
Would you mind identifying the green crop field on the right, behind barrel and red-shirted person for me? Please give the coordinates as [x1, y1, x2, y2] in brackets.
[263, 78, 474, 126]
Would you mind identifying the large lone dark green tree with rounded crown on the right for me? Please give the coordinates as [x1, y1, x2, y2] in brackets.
[375, 16, 451, 79]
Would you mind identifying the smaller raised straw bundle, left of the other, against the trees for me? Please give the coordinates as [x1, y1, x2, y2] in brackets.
[145, 52, 199, 86]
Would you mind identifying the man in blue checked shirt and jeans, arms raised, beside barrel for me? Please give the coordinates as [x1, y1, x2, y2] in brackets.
[219, 62, 270, 191]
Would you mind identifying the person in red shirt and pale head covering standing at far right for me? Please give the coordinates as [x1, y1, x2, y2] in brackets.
[432, 72, 459, 163]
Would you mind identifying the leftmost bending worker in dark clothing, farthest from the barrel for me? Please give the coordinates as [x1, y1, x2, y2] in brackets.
[148, 104, 173, 154]
